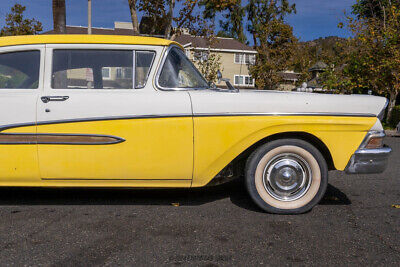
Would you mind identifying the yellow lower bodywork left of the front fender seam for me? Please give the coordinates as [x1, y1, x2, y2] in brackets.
[0, 117, 193, 186]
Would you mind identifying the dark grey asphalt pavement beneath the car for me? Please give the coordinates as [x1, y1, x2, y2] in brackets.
[0, 137, 400, 266]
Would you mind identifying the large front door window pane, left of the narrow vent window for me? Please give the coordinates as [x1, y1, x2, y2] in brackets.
[51, 49, 133, 89]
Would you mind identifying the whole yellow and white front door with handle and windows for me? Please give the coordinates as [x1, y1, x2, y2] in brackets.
[37, 44, 193, 180]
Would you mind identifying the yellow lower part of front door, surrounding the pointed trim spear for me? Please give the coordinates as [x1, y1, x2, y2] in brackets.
[38, 117, 193, 180]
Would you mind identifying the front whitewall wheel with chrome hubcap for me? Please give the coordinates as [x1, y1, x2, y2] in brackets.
[246, 139, 328, 214]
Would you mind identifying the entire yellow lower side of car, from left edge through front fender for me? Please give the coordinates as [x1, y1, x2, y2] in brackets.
[0, 116, 377, 187]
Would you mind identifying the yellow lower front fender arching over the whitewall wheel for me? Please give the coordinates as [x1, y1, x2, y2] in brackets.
[192, 116, 377, 187]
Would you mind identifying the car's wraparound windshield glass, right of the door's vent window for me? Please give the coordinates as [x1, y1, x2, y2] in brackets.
[158, 47, 210, 89]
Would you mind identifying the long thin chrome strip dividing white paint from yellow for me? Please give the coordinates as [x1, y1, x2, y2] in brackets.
[0, 112, 376, 132]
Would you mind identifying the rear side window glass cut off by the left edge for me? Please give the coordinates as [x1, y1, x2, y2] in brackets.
[0, 51, 40, 89]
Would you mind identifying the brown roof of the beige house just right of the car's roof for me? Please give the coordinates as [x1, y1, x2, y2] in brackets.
[174, 34, 257, 54]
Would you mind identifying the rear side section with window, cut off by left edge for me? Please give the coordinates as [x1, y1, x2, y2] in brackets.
[0, 45, 44, 185]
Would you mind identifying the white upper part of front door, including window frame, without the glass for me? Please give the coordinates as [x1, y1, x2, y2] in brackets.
[38, 44, 192, 122]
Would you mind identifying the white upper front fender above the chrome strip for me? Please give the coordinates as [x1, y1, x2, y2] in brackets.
[190, 90, 386, 116]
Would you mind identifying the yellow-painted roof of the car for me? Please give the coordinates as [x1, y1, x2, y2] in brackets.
[0, 34, 181, 47]
